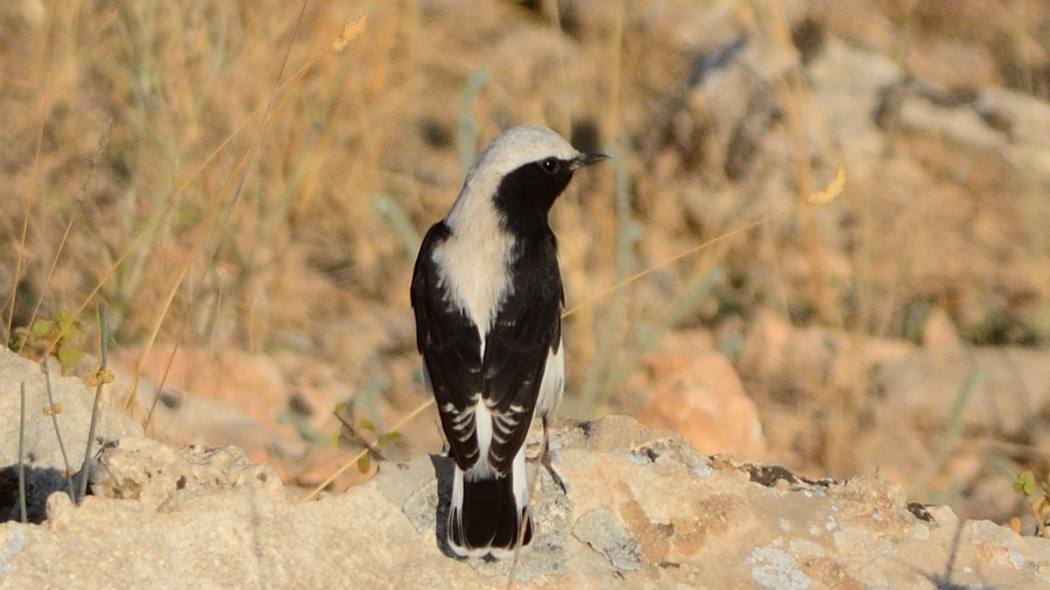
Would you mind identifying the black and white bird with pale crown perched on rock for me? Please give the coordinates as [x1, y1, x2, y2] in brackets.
[412, 125, 607, 559]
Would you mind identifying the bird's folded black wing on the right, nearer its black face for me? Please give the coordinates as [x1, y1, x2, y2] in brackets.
[482, 233, 564, 475]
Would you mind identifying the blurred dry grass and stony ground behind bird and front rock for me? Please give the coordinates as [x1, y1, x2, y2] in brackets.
[0, 0, 1050, 530]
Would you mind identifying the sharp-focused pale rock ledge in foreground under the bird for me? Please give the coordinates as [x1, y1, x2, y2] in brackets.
[0, 417, 1050, 590]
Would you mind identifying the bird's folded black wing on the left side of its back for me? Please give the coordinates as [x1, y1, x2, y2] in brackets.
[411, 222, 482, 470]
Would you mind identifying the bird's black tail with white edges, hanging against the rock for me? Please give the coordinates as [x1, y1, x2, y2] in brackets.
[448, 465, 532, 559]
